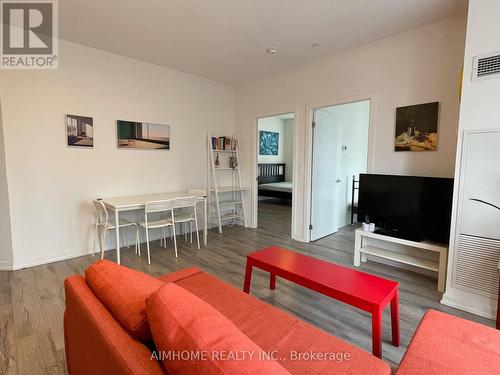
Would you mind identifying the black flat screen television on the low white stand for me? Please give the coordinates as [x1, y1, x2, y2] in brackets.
[358, 174, 453, 243]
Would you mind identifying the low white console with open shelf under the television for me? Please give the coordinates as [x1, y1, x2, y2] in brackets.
[354, 229, 448, 293]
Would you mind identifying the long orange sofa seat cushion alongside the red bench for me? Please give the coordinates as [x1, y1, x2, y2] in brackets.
[176, 272, 391, 375]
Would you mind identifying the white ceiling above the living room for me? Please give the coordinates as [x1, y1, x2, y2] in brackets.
[59, 0, 467, 86]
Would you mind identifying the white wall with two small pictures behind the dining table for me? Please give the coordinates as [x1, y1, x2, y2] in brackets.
[0, 41, 234, 268]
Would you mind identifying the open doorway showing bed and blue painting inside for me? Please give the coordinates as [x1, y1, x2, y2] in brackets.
[254, 113, 295, 237]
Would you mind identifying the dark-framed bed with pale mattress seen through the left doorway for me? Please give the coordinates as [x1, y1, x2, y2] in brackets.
[257, 163, 293, 199]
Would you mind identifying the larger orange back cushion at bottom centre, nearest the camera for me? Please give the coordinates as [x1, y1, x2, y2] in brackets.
[146, 283, 288, 375]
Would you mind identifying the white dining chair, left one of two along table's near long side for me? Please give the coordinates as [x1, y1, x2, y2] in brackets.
[139, 199, 177, 264]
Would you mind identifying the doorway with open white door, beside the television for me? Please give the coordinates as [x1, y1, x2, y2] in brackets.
[309, 100, 370, 241]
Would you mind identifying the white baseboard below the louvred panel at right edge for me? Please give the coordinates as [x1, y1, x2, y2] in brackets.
[441, 288, 497, 319]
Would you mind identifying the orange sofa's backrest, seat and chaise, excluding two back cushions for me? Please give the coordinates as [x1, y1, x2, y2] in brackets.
[64, 261, 500, 375]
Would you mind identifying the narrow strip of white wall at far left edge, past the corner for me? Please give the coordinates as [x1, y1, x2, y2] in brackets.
[0, 103, 12, 270]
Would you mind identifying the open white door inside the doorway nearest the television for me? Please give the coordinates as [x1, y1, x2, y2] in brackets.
[311, 110, 343, 241]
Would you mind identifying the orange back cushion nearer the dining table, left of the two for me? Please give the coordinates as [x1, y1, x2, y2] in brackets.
[85, 260, 165, 341]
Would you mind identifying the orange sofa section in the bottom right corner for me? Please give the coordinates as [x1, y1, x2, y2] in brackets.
[397, 310, 500, 375]
